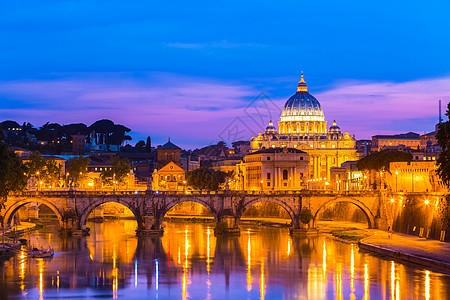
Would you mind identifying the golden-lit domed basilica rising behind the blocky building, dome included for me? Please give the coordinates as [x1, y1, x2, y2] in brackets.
[250, 74, 358, 187]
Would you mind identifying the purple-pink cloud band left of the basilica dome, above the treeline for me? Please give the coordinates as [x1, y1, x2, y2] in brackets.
[0, 75, 256, 144]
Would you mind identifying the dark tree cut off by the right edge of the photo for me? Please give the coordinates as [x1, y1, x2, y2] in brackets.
[436, 103, 450, 188]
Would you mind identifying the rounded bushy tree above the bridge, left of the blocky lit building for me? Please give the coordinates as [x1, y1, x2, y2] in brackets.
[187, 167, 228, 191]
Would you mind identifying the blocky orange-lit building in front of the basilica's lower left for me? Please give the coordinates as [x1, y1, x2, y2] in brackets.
[235, 147, 308, 191]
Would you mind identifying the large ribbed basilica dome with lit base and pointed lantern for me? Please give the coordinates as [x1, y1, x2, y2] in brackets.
[281, 74, 325, 121]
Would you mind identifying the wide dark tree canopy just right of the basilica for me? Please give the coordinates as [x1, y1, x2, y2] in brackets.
[356, 150, 412, 172]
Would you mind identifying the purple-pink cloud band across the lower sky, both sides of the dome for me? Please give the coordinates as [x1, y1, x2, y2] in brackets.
[0, 73, 450, 148]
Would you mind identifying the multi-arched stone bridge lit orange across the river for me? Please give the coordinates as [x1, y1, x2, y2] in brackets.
[1, 191, 414, 235]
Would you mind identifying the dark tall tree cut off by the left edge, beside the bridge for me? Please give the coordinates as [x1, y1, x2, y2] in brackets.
[0, 130, 27, 206]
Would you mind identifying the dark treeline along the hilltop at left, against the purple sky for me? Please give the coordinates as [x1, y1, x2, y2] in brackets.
[0, 120, 131, 154]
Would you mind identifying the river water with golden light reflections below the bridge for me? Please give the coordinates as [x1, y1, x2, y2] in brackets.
[0, 220, 450, 299]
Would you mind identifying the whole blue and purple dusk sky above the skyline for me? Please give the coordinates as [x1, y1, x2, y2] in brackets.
[0, 0, 450, 149]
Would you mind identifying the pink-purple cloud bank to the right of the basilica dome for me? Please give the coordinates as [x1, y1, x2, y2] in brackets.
[316, 78, 450, 138]
